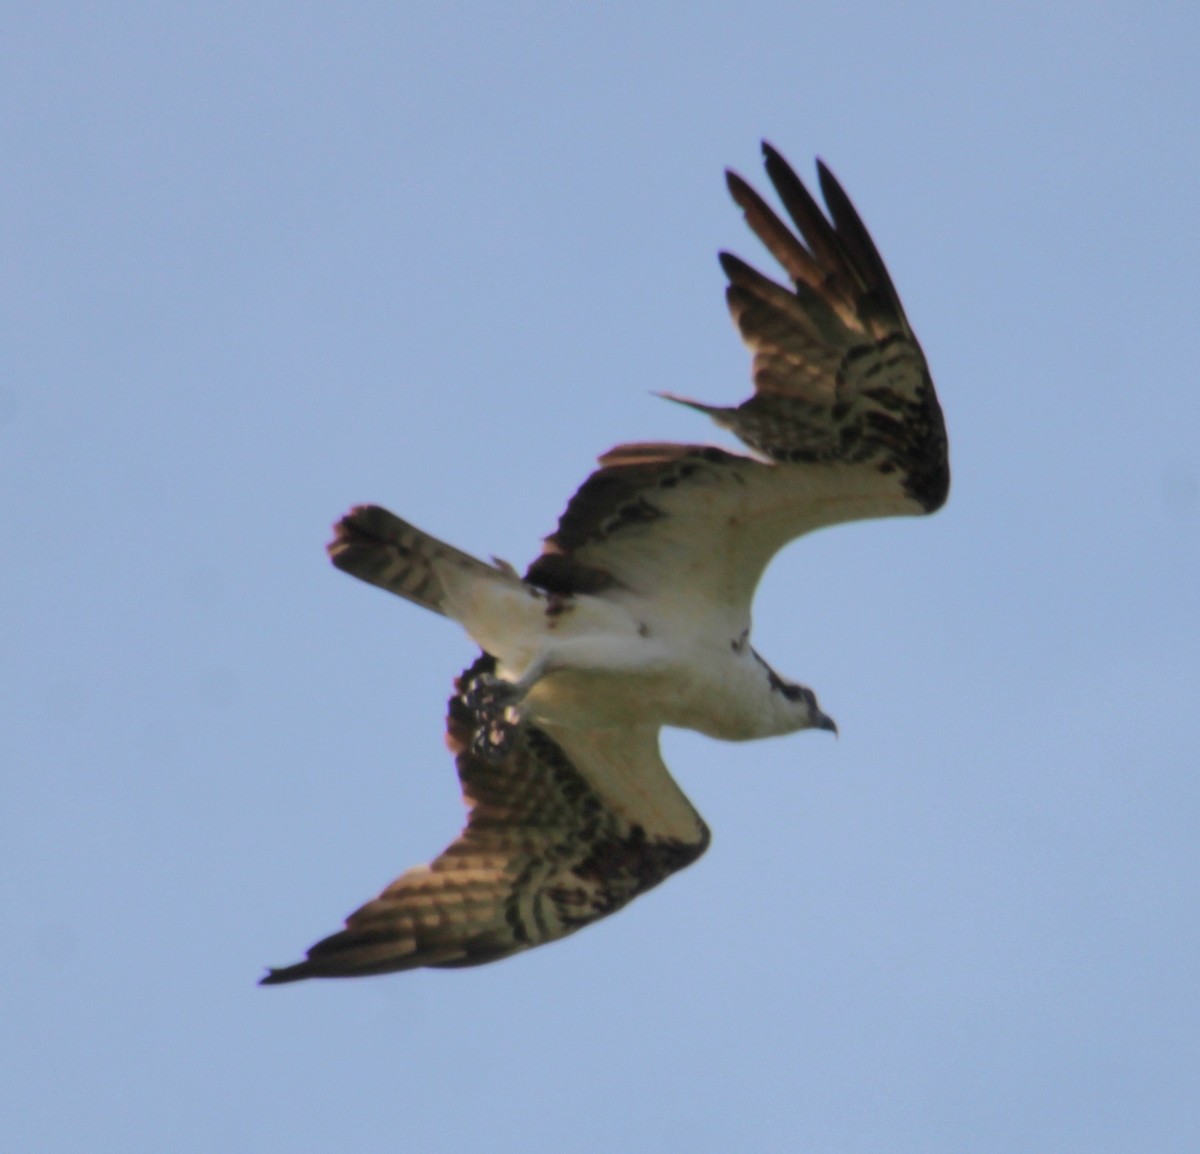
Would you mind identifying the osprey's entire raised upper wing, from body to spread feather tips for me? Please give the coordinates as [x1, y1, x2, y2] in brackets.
[527, 144, 949, 619]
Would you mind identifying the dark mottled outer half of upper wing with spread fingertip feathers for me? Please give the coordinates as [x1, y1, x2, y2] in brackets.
[700, 144, 949, 512]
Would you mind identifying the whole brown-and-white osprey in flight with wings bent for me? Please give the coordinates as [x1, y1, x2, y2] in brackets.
[262, 137, 949, 985]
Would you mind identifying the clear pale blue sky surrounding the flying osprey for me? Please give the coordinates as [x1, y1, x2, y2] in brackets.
[0, 2, 1200, 1154]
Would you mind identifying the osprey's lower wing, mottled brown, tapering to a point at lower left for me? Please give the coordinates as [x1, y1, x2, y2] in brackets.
[262, 654, 708, 985]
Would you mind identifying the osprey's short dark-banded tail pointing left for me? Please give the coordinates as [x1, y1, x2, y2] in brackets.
[329, 505, 521, 615]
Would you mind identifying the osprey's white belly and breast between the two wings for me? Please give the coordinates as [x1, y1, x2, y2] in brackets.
[439, 556, 812, 741]
